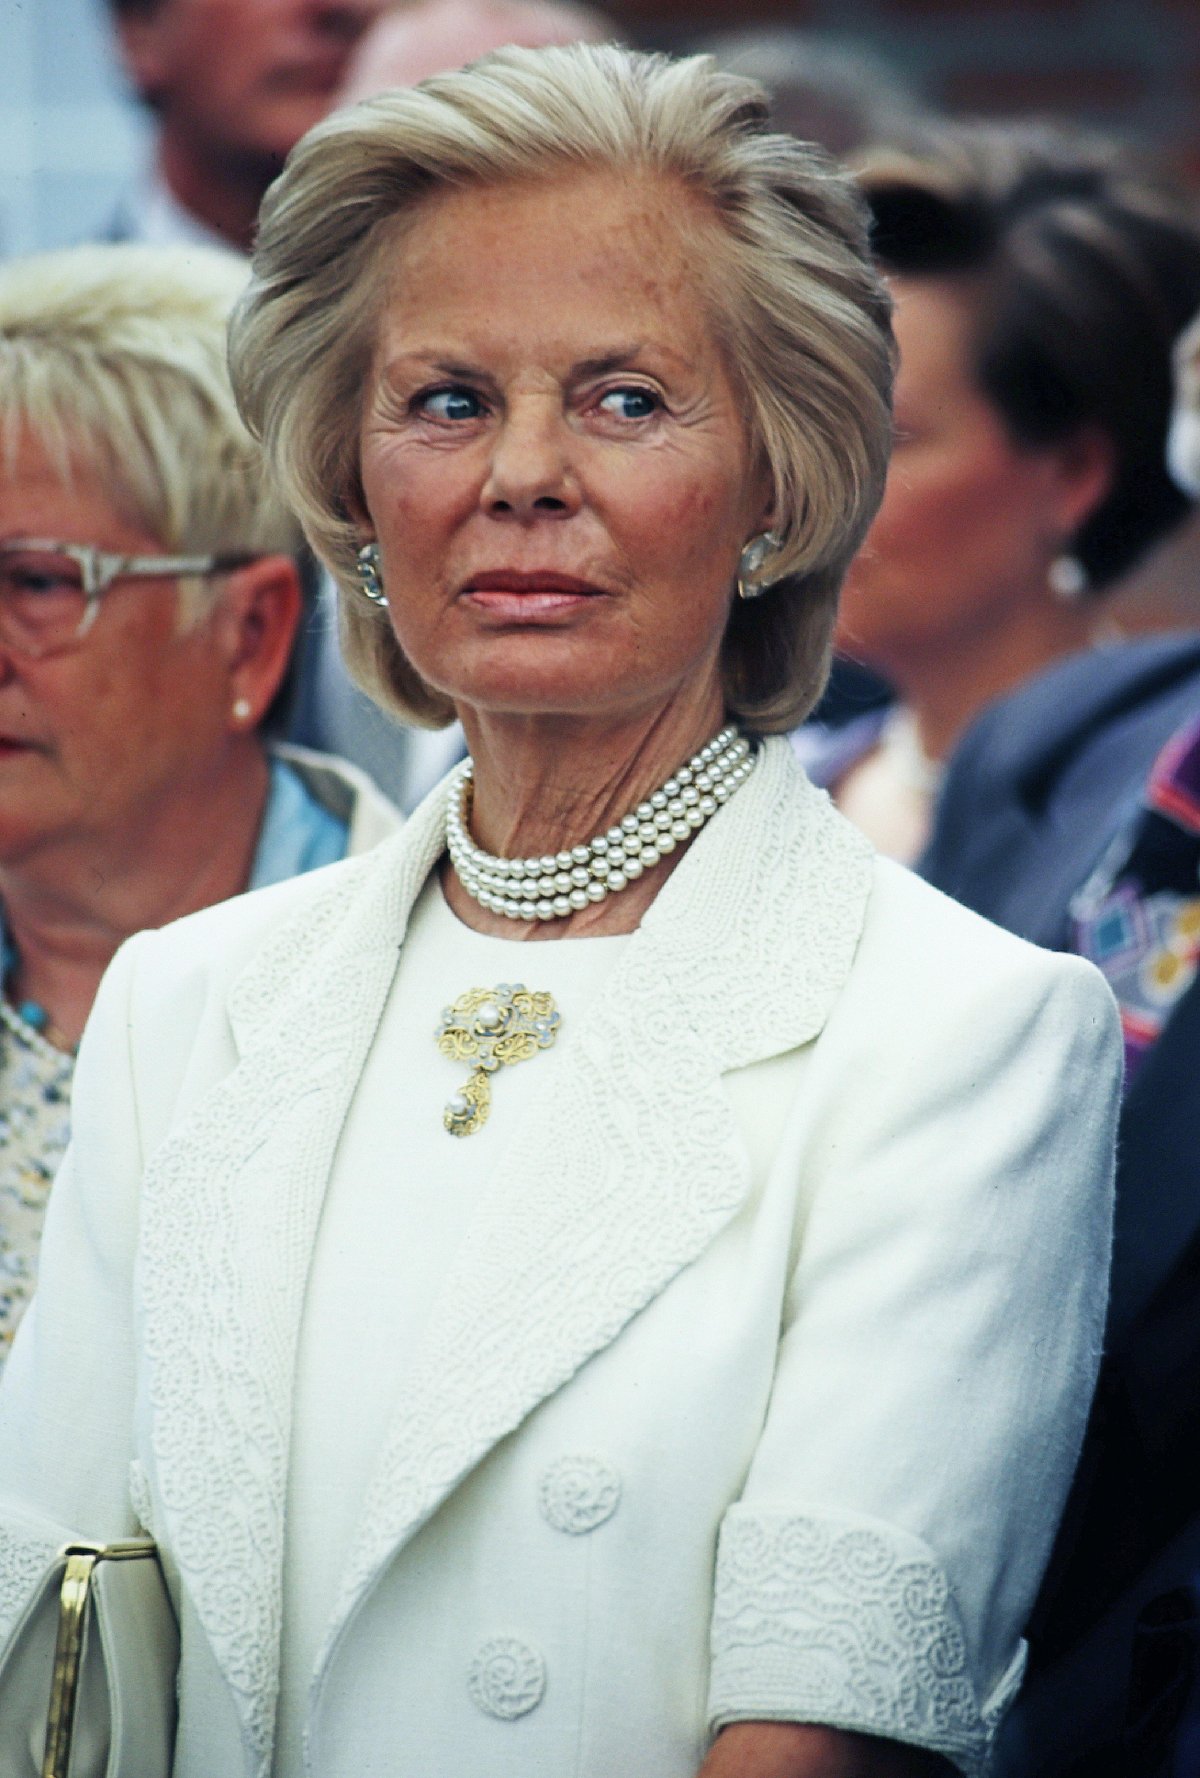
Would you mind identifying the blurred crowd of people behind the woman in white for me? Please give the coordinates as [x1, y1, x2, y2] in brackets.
[0, 0, 1200, 1778]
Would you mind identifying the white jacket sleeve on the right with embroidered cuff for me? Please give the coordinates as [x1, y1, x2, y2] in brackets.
[709, 935, 1120, 1774]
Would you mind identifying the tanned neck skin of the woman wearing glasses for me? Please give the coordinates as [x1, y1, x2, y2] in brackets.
[0, 736, 270, 1047]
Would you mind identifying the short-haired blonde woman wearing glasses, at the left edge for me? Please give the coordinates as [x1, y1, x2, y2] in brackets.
[0, 247, 403, 1362]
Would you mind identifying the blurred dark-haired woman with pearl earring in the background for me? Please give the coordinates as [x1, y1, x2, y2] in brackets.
[798, 124, 1200, 862]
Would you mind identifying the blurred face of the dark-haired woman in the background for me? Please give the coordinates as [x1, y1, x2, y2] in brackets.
[837, 277, 1077, 679]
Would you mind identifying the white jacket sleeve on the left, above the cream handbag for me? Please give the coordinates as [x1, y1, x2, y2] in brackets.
[0, 939, 142, 1636]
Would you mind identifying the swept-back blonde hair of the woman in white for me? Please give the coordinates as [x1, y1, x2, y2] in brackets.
[231, 44, 894, 733]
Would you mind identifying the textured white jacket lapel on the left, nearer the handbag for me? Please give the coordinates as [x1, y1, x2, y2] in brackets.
[140, 785, 441, 1773]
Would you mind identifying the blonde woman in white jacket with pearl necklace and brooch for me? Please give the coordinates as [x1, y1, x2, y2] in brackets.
[0, 46, 1120, 1778]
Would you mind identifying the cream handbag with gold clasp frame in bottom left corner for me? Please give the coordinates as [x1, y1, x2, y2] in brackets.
[0, 1538, 180, 1778]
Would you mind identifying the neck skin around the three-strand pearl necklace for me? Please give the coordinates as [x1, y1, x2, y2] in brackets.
[441, 688, 725, 941]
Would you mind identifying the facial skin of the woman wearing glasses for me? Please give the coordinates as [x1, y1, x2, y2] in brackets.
[0, 439, 243, 866]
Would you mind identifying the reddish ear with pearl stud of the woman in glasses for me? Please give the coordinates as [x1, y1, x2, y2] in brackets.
[215, 555, 304, 729]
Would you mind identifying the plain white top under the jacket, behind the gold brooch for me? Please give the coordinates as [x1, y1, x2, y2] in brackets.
[274, 873, 629, 1778]
